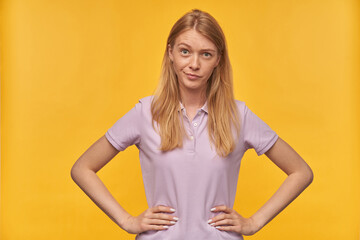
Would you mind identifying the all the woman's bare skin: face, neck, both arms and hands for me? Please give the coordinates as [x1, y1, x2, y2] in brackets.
[71, 27, 313, 235]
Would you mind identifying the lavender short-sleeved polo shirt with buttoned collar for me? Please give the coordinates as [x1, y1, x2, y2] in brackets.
[105, 96, 278, 240]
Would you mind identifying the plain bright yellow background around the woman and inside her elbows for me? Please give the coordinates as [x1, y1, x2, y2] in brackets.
[0, 0, 360, 240]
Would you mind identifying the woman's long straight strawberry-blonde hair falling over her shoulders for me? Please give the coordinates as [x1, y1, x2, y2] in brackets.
[151, 9, 240, 157]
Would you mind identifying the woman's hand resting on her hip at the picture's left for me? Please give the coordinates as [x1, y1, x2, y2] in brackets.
[121, 205, 179, 234]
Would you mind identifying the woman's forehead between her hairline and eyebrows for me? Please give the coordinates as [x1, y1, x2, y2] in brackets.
[175, 29, 216, 50]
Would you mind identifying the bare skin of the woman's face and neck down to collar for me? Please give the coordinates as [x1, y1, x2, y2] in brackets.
[168, 29, 220, 121]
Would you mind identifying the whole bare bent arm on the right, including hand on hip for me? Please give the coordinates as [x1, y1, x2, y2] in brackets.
[208, 137, 313, 235]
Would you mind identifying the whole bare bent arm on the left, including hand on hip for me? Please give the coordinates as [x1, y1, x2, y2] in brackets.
[71, 136, 178, 234]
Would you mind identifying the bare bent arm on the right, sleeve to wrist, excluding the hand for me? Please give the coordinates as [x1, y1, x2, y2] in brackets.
[251, 137, 313, 230]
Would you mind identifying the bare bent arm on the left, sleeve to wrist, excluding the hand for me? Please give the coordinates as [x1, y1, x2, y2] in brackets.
[71, 136, 131, 228]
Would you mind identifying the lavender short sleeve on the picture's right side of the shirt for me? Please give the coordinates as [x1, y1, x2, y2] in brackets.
[243, 105, 279, 156]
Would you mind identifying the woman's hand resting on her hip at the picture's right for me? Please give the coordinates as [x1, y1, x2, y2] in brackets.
[208, 205, 260, 236]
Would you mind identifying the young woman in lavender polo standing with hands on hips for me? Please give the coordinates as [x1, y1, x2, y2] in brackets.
[71, 9, 313, 240]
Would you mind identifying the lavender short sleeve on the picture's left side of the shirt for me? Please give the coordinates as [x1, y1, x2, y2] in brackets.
[105, 101, 141, 151]
